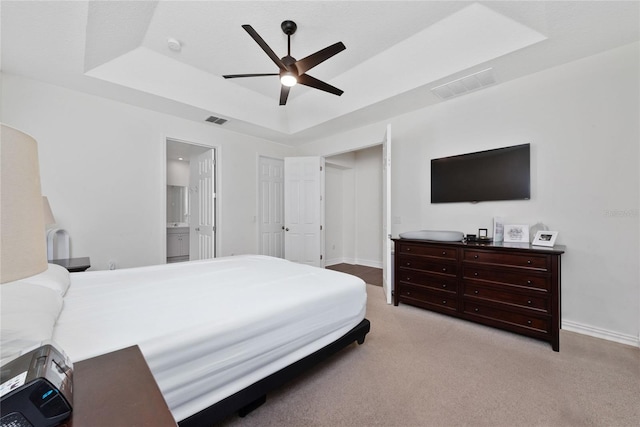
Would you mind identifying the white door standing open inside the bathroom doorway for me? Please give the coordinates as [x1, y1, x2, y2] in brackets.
[189, 150, 216, 260]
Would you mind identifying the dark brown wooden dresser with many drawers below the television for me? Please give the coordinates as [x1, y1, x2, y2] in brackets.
[393, 239, 565, 351]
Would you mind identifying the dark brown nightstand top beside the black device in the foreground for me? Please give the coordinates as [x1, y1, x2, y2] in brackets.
[61, 345, 177, 427]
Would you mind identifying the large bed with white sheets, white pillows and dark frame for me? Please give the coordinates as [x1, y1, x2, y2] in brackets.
[0, 255, 369, 426]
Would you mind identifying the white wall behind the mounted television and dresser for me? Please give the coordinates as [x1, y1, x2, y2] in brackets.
[300, 43, 640, 345]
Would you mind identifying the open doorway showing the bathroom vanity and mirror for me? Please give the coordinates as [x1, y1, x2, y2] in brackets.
[166, 138, 217, 263]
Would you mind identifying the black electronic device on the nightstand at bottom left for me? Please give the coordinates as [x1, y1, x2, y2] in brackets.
[0, 344, 73, 427]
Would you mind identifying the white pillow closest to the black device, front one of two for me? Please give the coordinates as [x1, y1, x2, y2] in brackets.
[0, 280, 62, 360]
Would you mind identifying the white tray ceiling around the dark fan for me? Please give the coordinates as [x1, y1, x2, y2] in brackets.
[0, 0, 640, 145]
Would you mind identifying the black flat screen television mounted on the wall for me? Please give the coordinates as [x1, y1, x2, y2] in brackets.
[431, 144, 531, 203]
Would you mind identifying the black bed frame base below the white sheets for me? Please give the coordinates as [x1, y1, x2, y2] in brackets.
[178, 319, 371, 427]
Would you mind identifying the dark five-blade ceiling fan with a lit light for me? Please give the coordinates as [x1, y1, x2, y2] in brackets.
[222, 21, 346, 105]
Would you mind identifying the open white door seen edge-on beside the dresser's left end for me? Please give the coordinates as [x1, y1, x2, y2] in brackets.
[382, 124, 393, 304]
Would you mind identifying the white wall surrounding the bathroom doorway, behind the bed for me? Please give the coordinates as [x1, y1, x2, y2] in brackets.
[1, 74, 293, 270]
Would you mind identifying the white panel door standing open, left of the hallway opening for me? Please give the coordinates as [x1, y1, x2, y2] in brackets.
[284, 157, 324, 267]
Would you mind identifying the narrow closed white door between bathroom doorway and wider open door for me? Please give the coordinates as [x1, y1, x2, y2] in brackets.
[258, 157, 284, 258]
